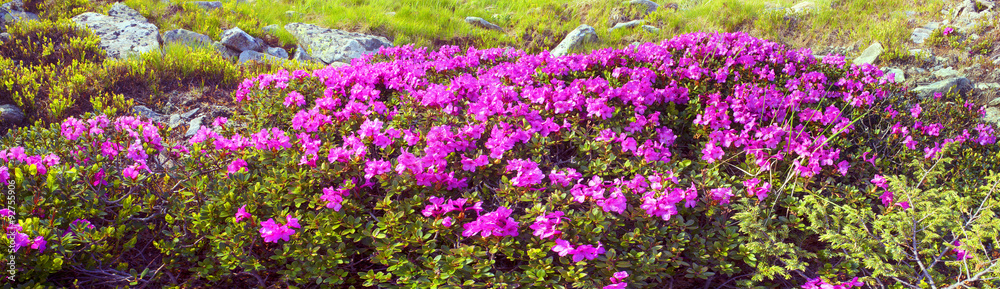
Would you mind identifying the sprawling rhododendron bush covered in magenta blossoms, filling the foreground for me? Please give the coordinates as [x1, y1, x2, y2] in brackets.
[0, 33, 1000, 288]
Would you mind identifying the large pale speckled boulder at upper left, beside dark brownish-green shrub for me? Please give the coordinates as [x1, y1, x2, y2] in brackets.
[73, 3, 163, 58]
